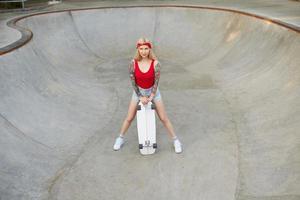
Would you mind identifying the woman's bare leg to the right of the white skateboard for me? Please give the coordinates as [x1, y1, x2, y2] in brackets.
[154, 100, 176, 139]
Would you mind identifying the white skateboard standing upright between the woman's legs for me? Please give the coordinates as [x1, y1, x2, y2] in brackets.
[137, 102, 157, 155]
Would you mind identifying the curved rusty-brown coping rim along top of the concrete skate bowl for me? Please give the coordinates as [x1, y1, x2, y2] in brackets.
[0, 4, 300, 56]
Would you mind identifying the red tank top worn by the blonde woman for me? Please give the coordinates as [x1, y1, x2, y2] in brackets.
[134, 60, 155, 89]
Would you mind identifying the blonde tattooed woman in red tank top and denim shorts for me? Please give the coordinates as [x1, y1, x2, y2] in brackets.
[113, 38, 182, 153]
